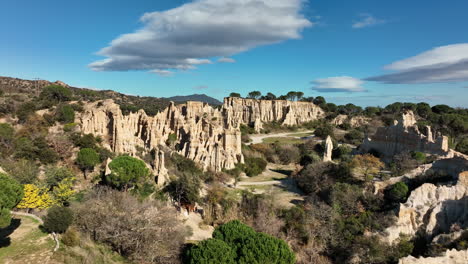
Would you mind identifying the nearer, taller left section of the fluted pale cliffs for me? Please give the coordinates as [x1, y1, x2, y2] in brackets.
[78, 100, 243, 174]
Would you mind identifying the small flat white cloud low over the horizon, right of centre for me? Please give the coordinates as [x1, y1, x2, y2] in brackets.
[312, 76, 365, 92]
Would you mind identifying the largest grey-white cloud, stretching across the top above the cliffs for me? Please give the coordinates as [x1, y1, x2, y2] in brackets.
[89, 0, 313, 74]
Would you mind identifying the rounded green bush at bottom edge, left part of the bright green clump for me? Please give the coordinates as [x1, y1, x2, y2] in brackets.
[186, 238, 237, 264]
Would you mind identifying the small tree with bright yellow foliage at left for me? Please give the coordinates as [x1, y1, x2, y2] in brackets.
[16, 184, 56, 209]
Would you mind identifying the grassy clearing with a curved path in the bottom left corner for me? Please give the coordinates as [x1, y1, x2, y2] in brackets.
[0, 216, 54, 263]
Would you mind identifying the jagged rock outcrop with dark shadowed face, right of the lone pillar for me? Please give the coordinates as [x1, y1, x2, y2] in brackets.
[361, 111, 449, 157]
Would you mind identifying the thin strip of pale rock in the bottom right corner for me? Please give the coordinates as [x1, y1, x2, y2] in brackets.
[398, 249, 468, 264]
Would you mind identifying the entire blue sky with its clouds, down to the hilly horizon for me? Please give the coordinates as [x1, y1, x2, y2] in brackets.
[0, 0, 468, 107]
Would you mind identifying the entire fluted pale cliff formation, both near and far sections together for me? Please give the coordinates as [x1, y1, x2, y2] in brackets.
[76, 98, 323, 183]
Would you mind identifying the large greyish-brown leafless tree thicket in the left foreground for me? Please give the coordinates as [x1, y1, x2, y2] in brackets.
[74, 188, 189, 263]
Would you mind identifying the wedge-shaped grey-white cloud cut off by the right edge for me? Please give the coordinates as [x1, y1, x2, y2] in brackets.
[367, 43, 468, 83]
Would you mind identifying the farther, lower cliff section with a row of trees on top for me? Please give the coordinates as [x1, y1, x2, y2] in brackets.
[223, 97, 324, 129]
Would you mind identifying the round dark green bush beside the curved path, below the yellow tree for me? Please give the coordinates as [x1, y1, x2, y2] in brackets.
[44, 206, 73, 234]
